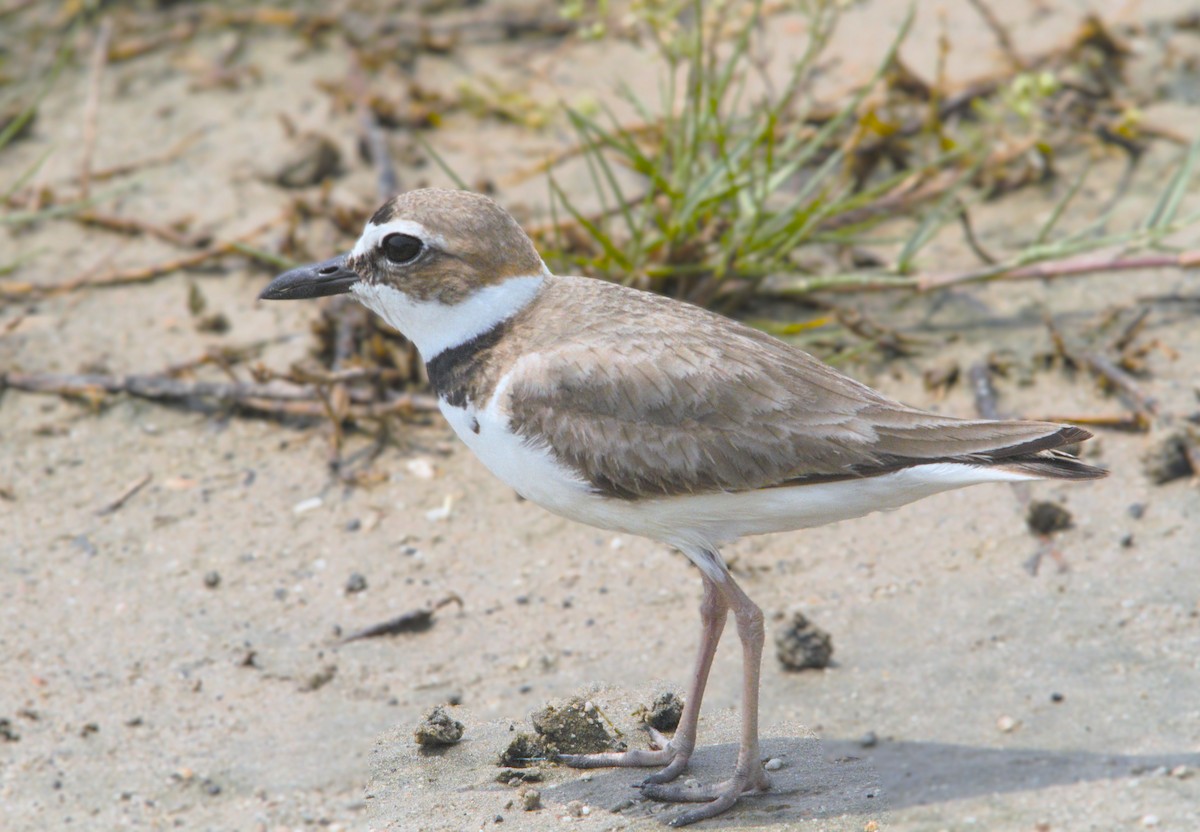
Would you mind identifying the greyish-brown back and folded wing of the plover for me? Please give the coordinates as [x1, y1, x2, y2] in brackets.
[506, 277, 1096, 498]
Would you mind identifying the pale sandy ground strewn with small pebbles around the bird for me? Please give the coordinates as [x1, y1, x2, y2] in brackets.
[0, 2, 1200, 832]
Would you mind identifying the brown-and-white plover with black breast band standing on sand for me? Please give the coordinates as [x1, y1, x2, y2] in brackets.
[262, 190, 1105, 826]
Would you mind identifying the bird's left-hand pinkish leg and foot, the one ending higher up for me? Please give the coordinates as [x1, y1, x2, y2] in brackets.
[559, 575, 730, 785]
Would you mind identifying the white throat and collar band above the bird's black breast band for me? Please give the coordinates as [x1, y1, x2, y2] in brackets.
[350, 275, 545, 363]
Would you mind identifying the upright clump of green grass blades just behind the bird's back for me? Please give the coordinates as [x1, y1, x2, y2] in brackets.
[550, 0, 912, 305]
